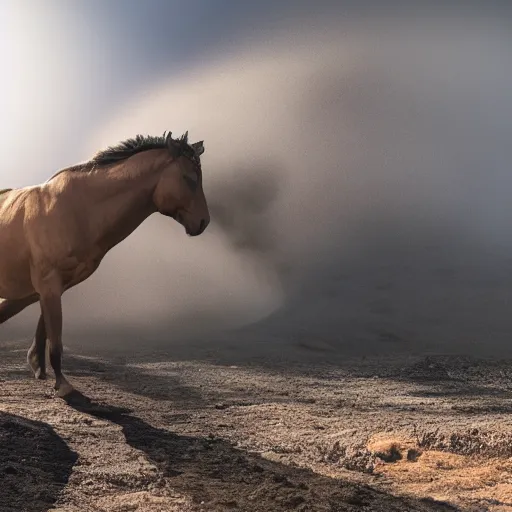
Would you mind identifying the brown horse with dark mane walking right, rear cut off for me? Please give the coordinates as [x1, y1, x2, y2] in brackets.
[0, 132, 210, 397]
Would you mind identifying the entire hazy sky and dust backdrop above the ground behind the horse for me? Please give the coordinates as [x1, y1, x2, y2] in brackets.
[0, 0, 512, 356]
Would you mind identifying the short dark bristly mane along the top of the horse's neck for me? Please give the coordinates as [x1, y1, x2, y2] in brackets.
[90, 132, 194, 166]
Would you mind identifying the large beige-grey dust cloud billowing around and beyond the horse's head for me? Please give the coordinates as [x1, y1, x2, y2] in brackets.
[4, 12, 512, 353]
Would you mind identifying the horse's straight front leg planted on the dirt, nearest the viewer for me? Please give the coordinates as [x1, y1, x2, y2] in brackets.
[40, 284, 73, 397]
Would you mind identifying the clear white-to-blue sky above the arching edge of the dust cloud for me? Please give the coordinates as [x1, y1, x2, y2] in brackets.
[0, 0, 510, 177]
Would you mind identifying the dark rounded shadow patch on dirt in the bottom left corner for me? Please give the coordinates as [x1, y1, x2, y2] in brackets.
[0, 412, 78, 512]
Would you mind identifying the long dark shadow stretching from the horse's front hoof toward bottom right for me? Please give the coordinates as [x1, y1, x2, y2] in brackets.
[68, 392, 460, 512]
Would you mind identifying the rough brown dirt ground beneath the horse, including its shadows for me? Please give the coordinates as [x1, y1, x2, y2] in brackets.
[0, 343, 512, 512]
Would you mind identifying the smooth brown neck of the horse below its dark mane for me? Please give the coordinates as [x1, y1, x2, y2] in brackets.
[79, 157, 162, 252]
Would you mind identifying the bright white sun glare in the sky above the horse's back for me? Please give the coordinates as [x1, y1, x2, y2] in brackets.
[0, 0, 94, 187]
